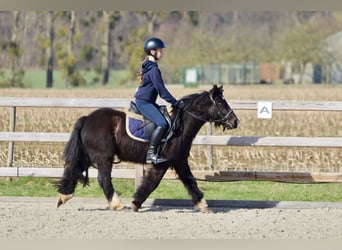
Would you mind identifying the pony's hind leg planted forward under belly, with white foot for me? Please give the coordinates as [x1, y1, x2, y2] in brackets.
[97, 162, 125, 211]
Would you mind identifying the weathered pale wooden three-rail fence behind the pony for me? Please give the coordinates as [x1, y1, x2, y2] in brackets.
[0, 97, 342, 183]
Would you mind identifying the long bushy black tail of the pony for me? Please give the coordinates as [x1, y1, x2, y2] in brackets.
[55, 116, 91, 194]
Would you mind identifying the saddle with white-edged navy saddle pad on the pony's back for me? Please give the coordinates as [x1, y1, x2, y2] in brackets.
[126, 101, 176, 142]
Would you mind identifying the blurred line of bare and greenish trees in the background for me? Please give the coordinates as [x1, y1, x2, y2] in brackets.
[0, 10, 342, 88]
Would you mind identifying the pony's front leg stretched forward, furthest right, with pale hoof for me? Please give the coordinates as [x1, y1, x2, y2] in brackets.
[175, 161, 209, 213]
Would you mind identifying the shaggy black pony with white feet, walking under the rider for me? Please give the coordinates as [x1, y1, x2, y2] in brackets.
[56, 85, 239, 212]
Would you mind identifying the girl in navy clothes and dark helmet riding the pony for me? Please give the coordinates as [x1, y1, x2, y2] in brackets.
[134, 37, 183, 164]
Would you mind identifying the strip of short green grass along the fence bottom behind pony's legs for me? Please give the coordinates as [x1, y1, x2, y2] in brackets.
[0, 177, 342, 202]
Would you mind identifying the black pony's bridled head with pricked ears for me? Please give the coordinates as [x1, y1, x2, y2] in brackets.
[182, 85, 240, 130]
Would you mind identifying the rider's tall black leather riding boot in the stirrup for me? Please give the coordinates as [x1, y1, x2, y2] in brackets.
[146, 127, 168, 164]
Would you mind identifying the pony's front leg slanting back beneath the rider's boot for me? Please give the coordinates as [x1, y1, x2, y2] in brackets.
[132, 164, 168, 212]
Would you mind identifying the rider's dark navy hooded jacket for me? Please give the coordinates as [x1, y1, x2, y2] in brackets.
[134, 60, 177, 106]
